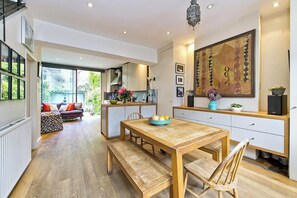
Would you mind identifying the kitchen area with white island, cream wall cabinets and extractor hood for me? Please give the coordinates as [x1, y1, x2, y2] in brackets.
[101, 63, 158, 139]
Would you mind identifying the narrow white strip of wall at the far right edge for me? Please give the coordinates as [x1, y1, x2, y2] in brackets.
[289, 0, 297, 181]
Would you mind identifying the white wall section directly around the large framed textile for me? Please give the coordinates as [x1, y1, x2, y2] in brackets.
[192, 13, 261, 111]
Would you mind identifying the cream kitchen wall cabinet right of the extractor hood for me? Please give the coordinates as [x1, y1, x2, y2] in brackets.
[122, 63, 147, 91]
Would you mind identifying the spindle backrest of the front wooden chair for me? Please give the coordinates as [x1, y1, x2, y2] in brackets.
[208, 139, 250, 185]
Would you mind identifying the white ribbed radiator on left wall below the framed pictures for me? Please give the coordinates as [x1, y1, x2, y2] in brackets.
[0, 118, 32, 198]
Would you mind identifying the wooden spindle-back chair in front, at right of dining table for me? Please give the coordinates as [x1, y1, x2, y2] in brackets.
[184, 139, 250, 198]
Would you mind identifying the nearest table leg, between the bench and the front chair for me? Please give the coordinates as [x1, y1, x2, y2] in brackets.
[171, 150, 184, 198]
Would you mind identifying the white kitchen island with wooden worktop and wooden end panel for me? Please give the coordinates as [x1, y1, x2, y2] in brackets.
[101, 102, 157, 139]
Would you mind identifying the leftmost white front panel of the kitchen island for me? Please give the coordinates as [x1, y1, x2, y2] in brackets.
[108, 107, 125, 138]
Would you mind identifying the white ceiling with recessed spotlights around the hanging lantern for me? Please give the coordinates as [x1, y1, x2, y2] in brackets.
[25, 0, 289, 69]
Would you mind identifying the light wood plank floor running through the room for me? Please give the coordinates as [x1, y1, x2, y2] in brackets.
[10, 117, 297, 198]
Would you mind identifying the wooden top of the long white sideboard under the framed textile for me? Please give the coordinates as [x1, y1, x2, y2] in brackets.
[173, 106, 289, 120]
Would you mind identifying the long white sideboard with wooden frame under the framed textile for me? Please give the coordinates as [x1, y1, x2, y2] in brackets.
[173, 106, 289, 157]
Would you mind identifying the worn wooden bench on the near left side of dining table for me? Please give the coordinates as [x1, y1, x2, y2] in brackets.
[107, 141, 172, 197]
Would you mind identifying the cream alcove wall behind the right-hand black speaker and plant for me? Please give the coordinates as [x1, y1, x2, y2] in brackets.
[260, 10, 290, 111]
